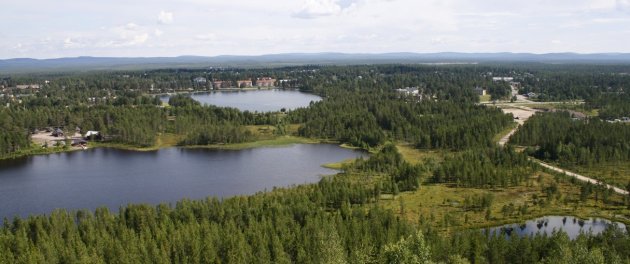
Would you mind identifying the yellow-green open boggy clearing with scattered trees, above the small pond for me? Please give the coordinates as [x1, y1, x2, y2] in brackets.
[386, 145, 630, 232]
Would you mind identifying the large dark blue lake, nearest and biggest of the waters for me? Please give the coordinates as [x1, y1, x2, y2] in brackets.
[0, 144, 366, 222]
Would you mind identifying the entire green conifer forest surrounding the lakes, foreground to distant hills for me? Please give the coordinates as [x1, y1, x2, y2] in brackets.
[0, 64, 630, 263]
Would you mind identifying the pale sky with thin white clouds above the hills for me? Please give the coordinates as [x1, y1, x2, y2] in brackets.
[0, 0, 630, 59]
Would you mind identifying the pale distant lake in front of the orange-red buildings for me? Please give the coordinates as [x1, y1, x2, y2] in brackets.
[160, 89, 322, 112]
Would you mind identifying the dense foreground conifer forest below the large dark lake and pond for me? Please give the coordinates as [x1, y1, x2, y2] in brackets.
[0, 168, 630, 263]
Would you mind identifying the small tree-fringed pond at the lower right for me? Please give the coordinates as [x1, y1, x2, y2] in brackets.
[489, 216, 626, 239]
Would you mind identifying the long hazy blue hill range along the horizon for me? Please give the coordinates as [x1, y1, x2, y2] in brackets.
[0, 52, 630, 73]
